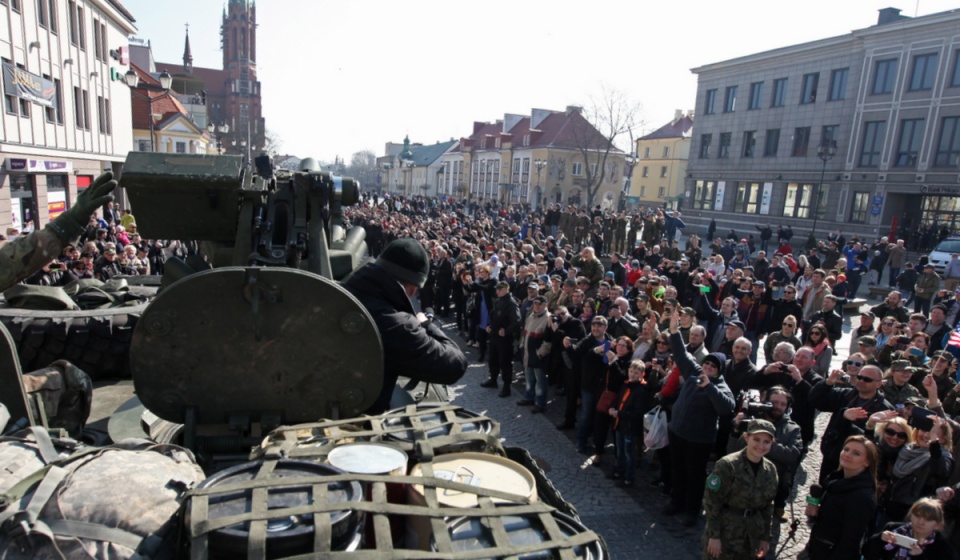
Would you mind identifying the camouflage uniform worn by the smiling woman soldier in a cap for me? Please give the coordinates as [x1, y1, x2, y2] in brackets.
[703, 449, 778, 560]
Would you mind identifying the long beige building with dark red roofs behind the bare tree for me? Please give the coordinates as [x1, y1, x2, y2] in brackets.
[440, 107, 624, 208]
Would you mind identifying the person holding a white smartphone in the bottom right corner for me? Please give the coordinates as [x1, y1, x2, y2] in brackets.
[861, 498, 957, 560]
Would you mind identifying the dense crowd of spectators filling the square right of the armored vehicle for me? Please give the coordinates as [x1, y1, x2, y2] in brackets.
[348, 198, 960, 559]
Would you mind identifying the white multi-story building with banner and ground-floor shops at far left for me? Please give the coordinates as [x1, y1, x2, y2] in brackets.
[0, 0, 136, 232]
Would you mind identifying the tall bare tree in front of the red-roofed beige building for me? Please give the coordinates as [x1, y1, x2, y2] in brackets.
[571, 87, 641, 208]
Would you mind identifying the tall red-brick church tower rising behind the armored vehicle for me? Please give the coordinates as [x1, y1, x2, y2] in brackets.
[218, 0, 264, 157]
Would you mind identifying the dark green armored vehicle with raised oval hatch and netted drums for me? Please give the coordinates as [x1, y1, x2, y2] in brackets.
[0, 152, 607, 559]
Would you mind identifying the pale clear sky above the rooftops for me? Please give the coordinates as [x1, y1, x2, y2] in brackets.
[121, 0, 960, 161]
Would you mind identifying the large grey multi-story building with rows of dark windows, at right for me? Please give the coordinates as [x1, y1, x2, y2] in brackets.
[684, 8, 960, 236]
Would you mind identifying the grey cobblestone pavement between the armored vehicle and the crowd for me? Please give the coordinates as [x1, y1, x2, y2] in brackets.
[444, 312, 851, 560]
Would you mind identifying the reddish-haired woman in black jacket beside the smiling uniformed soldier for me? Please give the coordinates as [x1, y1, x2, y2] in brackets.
[806, 436, 878, 560]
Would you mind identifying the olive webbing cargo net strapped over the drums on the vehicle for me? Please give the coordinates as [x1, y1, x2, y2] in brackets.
[185, 405, 605, 560]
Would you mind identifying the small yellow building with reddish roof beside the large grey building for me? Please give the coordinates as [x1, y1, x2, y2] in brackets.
[629, 110, 693, 208]
